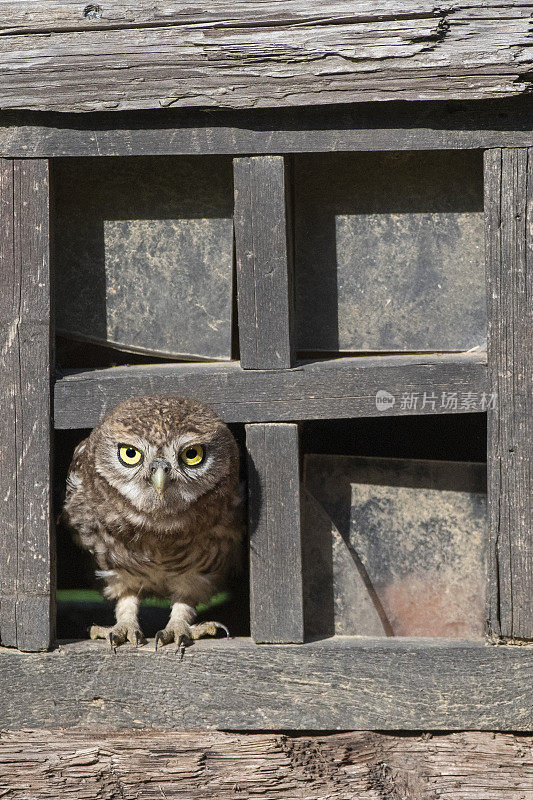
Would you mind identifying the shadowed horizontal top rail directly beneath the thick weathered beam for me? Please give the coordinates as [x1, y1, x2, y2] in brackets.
[0, 102, 533, 158]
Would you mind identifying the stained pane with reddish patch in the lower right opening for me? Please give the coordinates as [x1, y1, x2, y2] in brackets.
[302, 455, 487, 638]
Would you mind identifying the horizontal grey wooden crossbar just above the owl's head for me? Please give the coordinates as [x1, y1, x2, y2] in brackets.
[54, 351, 487, 428]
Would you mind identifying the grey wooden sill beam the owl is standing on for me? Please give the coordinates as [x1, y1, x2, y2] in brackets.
[0, 637, 533, 732]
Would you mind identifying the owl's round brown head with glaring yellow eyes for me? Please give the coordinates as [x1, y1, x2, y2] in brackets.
[90, 397, 239, 513]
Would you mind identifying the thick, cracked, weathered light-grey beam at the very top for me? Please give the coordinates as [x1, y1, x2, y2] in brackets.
[0, 0, 532, 111]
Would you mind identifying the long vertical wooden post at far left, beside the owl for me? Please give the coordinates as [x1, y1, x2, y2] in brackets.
[0, 159, 55, 650]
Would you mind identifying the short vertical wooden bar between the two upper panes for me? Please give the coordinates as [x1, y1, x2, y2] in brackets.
[233, 156, 294, 369]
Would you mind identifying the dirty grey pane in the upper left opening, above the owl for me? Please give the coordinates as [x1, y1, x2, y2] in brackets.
[53, 157, 233, 366]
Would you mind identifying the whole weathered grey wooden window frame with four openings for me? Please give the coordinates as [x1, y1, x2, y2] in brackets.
[0, 102, 533, 731]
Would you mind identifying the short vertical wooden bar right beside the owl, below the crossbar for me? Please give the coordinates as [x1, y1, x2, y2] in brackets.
[246, 423, 304, 642]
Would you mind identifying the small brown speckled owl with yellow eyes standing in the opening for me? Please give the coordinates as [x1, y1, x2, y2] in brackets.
[63, 397, 243, 646]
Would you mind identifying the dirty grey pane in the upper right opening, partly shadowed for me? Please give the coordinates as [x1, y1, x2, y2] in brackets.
[295, 151, 486, 352]
